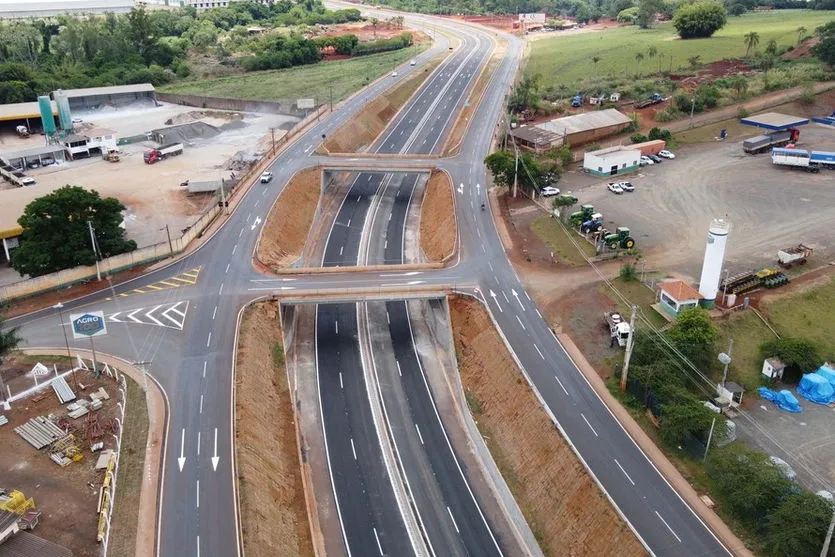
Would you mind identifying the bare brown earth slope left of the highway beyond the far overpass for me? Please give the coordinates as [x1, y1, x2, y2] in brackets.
[318, 56, 443, 155]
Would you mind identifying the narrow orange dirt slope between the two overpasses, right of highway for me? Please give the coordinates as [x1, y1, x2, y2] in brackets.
[420, 170, 458, 263]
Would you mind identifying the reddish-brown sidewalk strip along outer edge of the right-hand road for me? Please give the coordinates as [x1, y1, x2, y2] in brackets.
[557, 333, 754, 557]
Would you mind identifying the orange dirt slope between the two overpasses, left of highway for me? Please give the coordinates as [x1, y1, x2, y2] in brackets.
[255, 168, 322, 270]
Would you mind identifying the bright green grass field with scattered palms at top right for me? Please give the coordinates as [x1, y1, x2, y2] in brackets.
[525, 10, 835, 89]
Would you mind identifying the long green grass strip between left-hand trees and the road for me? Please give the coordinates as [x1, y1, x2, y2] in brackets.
[160, 44, 428, 104]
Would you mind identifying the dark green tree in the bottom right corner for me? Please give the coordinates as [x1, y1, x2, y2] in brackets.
[763, 491, 832, 557]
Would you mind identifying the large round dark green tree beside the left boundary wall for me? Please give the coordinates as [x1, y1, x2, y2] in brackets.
[12, 186, 136, 277]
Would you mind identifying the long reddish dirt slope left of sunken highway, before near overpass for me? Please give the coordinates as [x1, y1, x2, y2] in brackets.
[235, 303, 314, 557]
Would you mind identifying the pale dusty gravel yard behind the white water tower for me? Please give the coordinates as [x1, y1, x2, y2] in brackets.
[560, 124, 835, 278]
